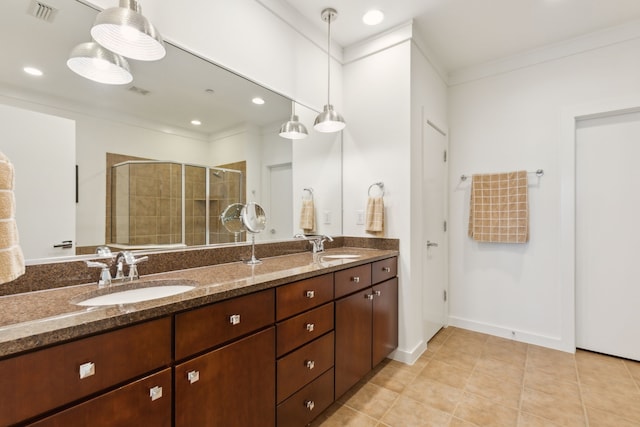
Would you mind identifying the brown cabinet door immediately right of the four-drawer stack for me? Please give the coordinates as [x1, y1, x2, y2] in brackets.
[335, 288, 373, 398]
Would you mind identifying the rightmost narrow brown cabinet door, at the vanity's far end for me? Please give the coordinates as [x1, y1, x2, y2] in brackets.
[372, 277, 398, 366]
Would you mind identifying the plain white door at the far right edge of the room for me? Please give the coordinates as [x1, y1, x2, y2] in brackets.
[576, 109, 640, 360]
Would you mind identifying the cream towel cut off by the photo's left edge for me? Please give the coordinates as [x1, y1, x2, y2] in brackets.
[0, 152, 24, 283]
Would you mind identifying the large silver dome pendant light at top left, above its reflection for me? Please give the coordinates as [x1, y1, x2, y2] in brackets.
[91, 0, 167, 61]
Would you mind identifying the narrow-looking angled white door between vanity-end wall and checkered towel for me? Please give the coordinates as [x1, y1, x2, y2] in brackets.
[422, 122, 447, 342]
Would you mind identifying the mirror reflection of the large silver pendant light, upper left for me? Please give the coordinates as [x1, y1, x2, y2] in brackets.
[67, 41, 133, 85]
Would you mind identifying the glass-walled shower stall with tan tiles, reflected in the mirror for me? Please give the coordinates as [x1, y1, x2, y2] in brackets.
[109, 160, 245, 249]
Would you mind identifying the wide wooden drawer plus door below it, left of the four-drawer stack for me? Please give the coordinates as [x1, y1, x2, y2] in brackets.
[174, 289, 276, 427]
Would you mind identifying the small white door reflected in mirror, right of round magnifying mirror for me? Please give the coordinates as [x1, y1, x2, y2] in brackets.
[265, 163, 294, 240]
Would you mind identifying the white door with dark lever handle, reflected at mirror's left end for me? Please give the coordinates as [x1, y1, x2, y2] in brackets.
[0, 105, 76, 259]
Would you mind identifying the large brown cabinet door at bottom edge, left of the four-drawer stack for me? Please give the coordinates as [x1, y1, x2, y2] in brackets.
[174, 327, 276, 427]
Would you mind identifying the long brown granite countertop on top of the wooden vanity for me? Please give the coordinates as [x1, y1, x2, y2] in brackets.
[0, 247, 398, 358]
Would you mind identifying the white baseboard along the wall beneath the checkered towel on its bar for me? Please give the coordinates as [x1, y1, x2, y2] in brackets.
[449, 316, 576, 353]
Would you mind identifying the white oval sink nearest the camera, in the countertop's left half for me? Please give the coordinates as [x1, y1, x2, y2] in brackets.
[74, 280, 196, 307]
